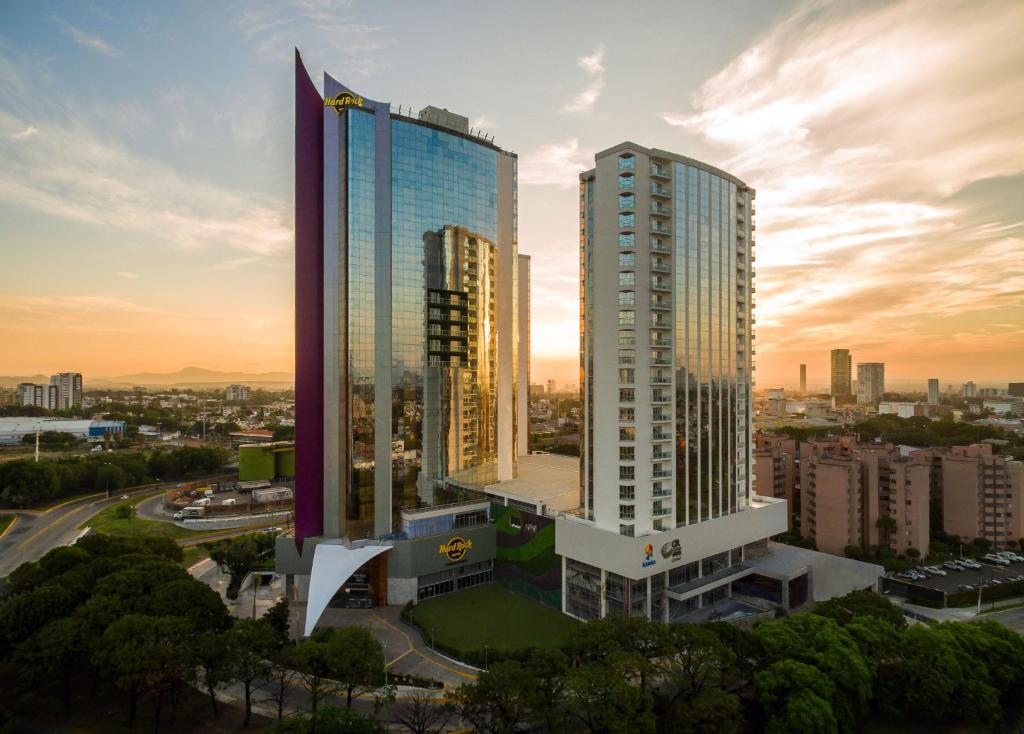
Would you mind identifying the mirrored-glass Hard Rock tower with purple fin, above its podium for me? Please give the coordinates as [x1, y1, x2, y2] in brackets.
[296, 52, 527, 543]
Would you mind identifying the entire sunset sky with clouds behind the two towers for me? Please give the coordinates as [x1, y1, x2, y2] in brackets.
[0, 0, 1024, 388]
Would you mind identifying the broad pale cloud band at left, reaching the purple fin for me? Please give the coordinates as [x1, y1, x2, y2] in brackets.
[0, 45, 292, 261]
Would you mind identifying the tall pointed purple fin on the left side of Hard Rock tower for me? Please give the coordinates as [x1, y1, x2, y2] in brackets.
[295, 49, 324, 552]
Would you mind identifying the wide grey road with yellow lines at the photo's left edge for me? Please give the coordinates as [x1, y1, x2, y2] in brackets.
[0, 487, 154, 578]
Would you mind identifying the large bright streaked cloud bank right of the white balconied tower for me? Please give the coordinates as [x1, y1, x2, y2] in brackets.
[662, 0, 1024, 382]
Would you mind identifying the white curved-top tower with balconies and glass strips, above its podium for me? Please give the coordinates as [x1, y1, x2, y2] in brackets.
[580, 143, 755, 535]
